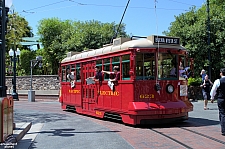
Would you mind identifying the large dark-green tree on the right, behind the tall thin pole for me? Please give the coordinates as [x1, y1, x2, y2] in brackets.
[164, 0, 225, 80]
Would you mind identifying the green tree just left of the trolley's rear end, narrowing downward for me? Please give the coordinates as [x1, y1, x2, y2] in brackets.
[38, 18, 68, 74]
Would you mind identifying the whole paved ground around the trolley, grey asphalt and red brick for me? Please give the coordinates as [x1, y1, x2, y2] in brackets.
[3, 99, 225, 149]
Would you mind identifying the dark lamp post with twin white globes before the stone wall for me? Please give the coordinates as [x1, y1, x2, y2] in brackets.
[9, 48, 20, 100]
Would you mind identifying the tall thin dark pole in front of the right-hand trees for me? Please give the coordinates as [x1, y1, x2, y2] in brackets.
[207, 0, 212, 79]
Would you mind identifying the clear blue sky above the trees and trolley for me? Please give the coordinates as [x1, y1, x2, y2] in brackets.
[11, 0, 206, 36]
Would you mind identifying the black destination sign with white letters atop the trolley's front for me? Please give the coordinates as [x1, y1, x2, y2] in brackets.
[154, 36, 180, 45]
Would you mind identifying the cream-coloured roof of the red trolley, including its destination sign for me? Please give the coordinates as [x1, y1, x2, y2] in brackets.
[62, 35, 186, 63]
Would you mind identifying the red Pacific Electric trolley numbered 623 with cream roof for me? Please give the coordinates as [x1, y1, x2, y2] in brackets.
[59, 35, 193, 125]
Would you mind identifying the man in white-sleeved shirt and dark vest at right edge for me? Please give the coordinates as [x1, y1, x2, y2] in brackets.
[210, 68, 225, 136]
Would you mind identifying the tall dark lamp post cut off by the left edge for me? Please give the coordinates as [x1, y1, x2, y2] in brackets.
[0, 0, 12, 97]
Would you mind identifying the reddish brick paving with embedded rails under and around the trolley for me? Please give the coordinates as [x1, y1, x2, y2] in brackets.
[12, 98, 225, 149]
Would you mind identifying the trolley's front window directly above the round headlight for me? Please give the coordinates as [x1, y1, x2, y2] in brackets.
[158, 53, 178, 80]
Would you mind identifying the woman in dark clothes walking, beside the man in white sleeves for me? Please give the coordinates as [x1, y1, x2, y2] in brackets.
[201, 75, 213, 110]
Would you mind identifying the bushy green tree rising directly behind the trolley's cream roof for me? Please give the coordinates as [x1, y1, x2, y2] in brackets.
[63, 20, 128, 52]
